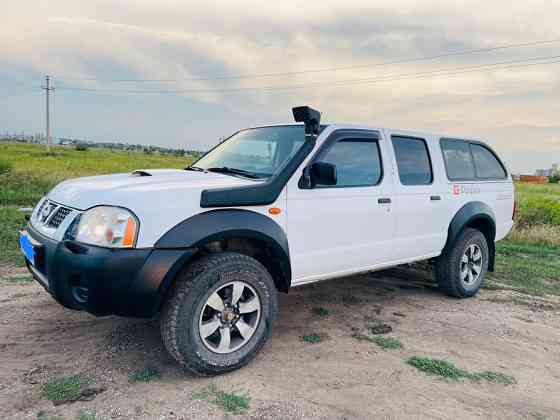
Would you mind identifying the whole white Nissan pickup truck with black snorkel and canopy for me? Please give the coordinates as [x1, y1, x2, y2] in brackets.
[20, 107, 515, 375]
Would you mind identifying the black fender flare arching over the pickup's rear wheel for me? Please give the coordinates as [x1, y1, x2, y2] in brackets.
[443, 201, 496, 271]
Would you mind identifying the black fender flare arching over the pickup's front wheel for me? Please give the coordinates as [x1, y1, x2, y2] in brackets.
[155, 209, 292, 293]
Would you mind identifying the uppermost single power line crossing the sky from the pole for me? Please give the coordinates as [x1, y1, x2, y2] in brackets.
[54, 38, 560, 83]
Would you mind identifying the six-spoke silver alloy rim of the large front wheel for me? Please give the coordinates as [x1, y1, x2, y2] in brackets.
[198, 281, 262, 354]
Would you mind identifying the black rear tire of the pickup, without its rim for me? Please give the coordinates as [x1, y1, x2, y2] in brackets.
[436, 228, 490, 298]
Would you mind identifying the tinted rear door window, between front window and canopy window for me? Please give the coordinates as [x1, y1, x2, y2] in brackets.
[392, 136, 433, 185]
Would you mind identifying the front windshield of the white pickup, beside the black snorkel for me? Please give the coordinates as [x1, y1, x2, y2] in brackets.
[193, 125, 305, 178]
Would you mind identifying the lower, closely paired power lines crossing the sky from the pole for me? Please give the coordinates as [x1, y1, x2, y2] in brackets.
[53, 55, 560, 94]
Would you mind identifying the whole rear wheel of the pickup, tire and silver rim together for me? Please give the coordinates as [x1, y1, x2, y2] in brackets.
[436, 228, 489, 298]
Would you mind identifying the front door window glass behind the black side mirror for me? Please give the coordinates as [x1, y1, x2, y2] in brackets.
[317, 138, 382, 187]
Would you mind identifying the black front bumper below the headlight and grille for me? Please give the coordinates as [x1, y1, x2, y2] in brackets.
[27, 227, 195, 318]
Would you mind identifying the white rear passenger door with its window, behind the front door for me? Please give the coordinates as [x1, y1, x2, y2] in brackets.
[388, 132, 449, 261]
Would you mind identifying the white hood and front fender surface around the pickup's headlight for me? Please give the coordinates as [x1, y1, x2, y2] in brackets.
[47, 169, 261, 247]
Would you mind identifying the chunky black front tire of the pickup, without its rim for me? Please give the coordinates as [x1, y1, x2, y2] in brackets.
[161, 253, 278, 376]
